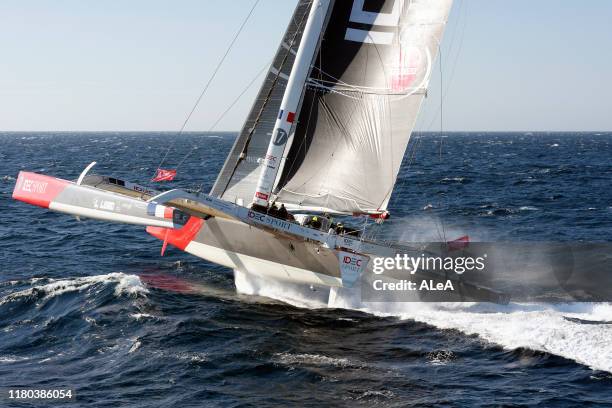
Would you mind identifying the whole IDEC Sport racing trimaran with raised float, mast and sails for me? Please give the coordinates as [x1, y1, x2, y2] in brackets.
[13, 0, 498, 300]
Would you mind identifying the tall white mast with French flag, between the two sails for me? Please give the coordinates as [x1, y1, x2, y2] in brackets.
[253, 0, 331, 207]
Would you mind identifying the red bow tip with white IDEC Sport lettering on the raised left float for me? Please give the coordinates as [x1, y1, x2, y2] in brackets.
[13, 171, 70, 208]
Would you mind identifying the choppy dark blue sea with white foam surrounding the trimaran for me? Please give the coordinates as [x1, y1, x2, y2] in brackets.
[0, 132, 612, 408]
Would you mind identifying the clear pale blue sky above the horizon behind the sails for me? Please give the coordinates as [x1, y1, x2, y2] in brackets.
[0, 0, 612, 131]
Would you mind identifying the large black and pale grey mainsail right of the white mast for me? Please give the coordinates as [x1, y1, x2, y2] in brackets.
[276, 0, 452, 213]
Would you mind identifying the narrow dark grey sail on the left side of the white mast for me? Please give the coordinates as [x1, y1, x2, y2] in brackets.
[210, 0, 311, 205]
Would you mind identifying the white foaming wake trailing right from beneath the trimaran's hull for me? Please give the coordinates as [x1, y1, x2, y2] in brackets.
[234, 271, 612, 372]
